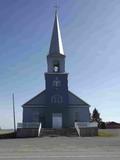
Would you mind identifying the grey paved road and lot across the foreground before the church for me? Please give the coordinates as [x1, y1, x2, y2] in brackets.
[0, 137, 120, 160]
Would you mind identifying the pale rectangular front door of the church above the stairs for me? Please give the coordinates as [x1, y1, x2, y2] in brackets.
[52, 113, 62, 128]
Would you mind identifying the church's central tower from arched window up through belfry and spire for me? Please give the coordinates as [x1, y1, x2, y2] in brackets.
[45, 12, 68, 106]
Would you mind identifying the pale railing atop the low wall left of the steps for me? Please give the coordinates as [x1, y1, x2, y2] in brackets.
[17, 122, 40, 128]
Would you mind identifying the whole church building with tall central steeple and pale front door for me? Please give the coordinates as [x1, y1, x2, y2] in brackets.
[22, 12, 90, 128]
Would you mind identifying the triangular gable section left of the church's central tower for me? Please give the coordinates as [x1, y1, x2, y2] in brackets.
[22, 90, 46, 107]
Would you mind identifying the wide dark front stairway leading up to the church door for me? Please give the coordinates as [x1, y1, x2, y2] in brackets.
[40, 128, 78, 137]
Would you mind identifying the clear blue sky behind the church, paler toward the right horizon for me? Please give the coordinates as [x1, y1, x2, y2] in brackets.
[0, 0, 120, 128]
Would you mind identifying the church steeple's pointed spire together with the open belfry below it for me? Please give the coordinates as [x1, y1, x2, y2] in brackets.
[47, 10, 65, 74]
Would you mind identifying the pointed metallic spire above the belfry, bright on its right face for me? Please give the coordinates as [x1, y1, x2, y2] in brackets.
[49, 10, 64, 55]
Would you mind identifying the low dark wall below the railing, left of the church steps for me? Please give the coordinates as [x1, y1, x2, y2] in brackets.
[16, 128, 38, 138]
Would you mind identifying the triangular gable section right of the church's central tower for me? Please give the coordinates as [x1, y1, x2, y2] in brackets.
[68, 91, 90, 106]
